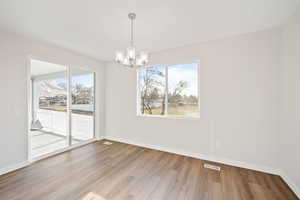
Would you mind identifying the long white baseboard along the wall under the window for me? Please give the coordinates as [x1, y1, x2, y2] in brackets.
[105, 136, 279, 175]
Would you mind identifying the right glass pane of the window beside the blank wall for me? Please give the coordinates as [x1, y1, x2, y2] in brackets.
[168, 63, 199, 117]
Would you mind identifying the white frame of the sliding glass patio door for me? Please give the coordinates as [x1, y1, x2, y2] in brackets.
[26, 56, 99, 162]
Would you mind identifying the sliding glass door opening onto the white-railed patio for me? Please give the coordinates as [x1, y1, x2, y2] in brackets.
[30, 60, 95, 158]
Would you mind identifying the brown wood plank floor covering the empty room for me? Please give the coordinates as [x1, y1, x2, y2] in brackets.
[0, 141, 298, 200]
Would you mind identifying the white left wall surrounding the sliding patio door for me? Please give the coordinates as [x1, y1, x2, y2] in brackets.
[0, 31, 105, 174]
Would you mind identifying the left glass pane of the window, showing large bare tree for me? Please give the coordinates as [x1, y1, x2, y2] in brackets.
[139, 66, 166, 115]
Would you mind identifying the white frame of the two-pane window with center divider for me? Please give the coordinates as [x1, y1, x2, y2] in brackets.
[136, 61, 201, 120]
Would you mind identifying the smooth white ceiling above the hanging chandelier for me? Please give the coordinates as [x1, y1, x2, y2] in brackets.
[0, 0, 300, 60]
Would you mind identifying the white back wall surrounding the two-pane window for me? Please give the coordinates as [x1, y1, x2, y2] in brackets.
[106, 29, 281, 171]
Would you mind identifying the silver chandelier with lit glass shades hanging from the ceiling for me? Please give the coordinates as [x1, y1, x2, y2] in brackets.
[115, 13, 148, 68]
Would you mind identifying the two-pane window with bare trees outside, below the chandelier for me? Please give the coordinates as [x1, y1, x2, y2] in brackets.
[138, 62, 200, 117]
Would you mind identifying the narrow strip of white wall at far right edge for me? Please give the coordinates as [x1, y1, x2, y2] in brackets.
[279, 10, 300, 197]
